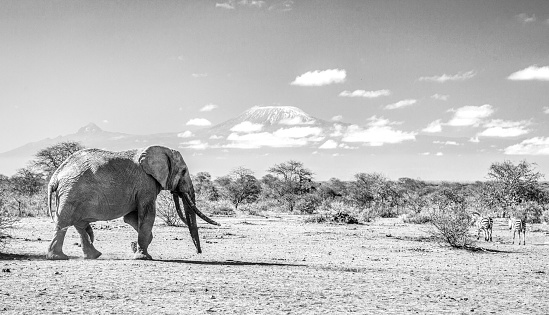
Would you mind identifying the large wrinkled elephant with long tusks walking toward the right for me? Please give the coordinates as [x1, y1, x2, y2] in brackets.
[46, 146, 220, 260]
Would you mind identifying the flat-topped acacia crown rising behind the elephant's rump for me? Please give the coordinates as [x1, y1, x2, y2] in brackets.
[31, 141, 84, 178]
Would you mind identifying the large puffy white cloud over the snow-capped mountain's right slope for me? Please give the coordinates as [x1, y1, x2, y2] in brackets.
[341, 121, 417, 146]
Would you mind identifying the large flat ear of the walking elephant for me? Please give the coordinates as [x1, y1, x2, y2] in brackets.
[139, 146, 173, 190]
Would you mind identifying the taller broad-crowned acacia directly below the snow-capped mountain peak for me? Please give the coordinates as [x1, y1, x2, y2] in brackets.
[262, 160, 314, 212]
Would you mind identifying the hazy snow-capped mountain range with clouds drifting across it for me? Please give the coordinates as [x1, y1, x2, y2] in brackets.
[0, 106, 474, 179]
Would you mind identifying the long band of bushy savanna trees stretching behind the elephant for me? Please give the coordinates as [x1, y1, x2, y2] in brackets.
[0, 141, 549, 230]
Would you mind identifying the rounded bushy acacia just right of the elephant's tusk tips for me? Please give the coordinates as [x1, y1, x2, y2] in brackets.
[215, 167, 261, 209]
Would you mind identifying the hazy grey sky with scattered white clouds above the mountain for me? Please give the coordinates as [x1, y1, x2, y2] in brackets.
[0, 0, 549, 180]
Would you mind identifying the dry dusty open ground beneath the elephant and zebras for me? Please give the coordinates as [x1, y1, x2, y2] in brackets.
[0, 215, 549, 314]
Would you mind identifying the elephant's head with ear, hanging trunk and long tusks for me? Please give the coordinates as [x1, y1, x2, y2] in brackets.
[138, 146, 220, 253]
